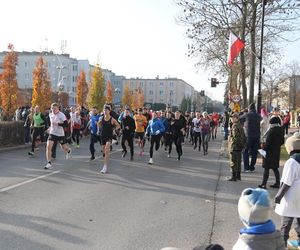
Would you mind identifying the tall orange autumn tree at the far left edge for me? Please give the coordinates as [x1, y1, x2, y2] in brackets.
[0, 44, 18, 120]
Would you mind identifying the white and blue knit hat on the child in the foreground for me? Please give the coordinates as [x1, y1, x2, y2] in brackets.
[238, 188, 271, 226]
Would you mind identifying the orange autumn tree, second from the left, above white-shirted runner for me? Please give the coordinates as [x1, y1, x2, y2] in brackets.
[31, 56, 52, 112]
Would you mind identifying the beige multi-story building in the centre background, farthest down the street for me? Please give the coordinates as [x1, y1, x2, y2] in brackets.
[123, 77, 194, 106]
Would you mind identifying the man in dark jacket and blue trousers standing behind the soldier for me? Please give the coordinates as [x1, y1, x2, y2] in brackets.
[241, 103, 261, 172]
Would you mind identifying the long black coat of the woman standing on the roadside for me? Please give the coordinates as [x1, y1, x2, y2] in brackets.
[263, 127, 284, 169]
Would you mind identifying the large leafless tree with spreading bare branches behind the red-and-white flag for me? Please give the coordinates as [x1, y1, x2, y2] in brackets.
[177, 0, 300, 105]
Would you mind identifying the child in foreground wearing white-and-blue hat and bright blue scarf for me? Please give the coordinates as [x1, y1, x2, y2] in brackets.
[232, 188, 285, 250]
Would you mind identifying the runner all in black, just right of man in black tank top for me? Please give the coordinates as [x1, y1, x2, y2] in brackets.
[121, 108, 135, 161]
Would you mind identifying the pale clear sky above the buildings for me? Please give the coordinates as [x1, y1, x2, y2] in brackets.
[0, 0, 299, 101]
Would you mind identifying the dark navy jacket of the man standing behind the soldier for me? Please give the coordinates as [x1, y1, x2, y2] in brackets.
[240, 110, 261, 138]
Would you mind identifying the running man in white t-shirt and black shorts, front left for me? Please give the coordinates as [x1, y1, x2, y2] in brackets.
[45, 103, 71, 169]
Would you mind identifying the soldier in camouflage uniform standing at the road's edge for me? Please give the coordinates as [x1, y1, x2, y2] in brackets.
[228, 113, 246, 181]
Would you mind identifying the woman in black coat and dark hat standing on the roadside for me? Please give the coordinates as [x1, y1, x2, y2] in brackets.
[259, 116, 284, 189]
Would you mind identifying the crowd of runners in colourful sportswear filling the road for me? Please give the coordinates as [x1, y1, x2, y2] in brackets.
[25, 103, 223, 173]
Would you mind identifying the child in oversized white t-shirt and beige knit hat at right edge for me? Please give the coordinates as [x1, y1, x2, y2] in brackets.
[275, 132, 300, 249]
